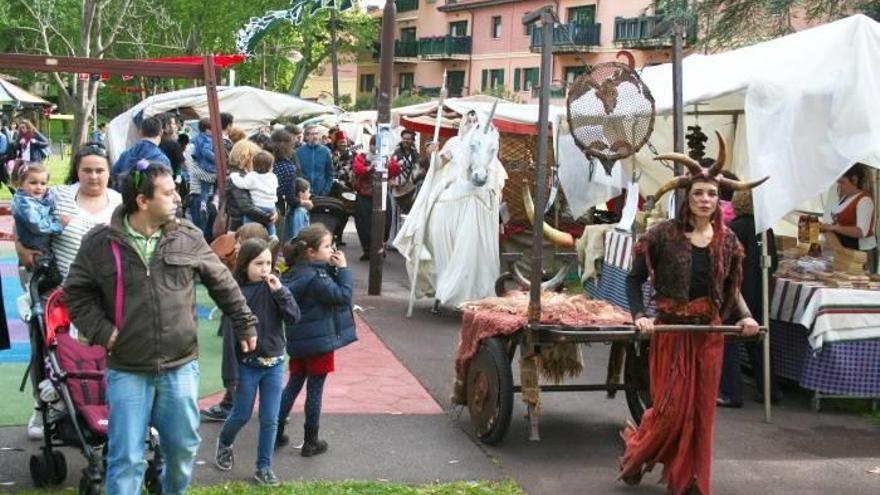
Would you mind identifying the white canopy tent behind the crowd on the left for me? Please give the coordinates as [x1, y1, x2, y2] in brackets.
[107, 86, 336, 160]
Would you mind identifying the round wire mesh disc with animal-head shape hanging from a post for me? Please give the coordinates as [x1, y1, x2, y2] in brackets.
[567, 62, 655, 174]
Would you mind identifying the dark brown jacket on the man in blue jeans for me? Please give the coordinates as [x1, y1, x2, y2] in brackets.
[64, 206, 257, 373]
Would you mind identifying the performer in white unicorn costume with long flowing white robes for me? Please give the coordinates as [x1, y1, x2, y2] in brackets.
[394, 109, 507, 307]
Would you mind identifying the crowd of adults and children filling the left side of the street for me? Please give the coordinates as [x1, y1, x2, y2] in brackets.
[0, 114, 410, 493]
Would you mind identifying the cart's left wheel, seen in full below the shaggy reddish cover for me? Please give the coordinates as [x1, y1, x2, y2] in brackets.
[467, 337, 513, 445]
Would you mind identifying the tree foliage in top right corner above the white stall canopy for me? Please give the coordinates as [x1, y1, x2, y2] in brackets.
[656, 0, 880, 51]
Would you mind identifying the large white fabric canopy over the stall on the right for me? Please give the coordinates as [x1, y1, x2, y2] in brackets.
[631, 15, 880, 231]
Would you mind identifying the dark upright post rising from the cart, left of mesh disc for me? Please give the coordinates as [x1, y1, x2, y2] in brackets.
[521, 5, 556, 441]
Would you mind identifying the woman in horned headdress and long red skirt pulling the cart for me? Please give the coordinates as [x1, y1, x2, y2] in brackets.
[620, 136, 766, 495]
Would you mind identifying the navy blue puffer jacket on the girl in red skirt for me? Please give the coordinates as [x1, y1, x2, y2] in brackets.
[282, 263, 357, 359]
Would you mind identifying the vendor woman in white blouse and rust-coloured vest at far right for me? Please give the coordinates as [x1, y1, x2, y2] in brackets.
[820, 163, 877, 272]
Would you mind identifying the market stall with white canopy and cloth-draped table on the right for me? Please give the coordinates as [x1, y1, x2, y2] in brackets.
[608, 15, 880, 405]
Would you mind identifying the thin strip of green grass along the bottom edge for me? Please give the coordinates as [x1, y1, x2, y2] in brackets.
[0, 481, 525, 495]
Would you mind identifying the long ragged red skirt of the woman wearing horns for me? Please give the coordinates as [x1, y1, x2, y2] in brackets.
[620, 298, 724, 495]
